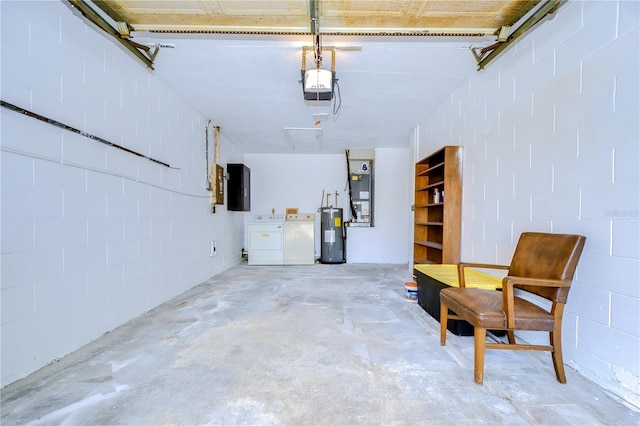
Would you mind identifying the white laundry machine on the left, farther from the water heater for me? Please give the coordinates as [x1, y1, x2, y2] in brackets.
[248, 215, 285, 265]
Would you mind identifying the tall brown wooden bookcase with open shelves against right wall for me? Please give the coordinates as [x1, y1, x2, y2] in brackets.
[413, 146, 462, 264]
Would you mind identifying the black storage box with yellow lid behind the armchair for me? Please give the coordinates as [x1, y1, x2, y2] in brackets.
[413, 264, 502, 336]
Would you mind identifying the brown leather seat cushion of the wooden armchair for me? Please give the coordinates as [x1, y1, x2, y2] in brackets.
[440, 288, 554, 331]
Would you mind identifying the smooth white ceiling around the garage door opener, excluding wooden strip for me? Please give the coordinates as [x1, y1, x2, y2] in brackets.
[133, 33, 484, 153]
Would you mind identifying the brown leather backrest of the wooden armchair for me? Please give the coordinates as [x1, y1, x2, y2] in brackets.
[509, 232, 586, 303]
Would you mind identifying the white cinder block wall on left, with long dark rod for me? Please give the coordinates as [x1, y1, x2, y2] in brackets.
[0, 1, 243, 386]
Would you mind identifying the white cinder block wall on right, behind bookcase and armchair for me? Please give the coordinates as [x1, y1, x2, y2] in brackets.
[417, 1, 640, 406]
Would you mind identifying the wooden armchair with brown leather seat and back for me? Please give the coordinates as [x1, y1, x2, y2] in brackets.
[440, 232, 586, 385]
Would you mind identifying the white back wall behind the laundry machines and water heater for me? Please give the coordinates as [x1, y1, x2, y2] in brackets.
[245, 148, 413, 264]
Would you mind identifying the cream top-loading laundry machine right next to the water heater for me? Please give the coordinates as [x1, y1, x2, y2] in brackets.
[284, 213, 316, 265]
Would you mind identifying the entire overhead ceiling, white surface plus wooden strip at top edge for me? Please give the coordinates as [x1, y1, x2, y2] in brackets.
[86, 0, 540, 153]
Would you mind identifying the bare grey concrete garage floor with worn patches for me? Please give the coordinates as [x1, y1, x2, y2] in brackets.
[1, 264, 640, 425]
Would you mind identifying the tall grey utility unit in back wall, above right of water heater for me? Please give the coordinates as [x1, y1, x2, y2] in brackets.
[347, 148, 375, 227]
